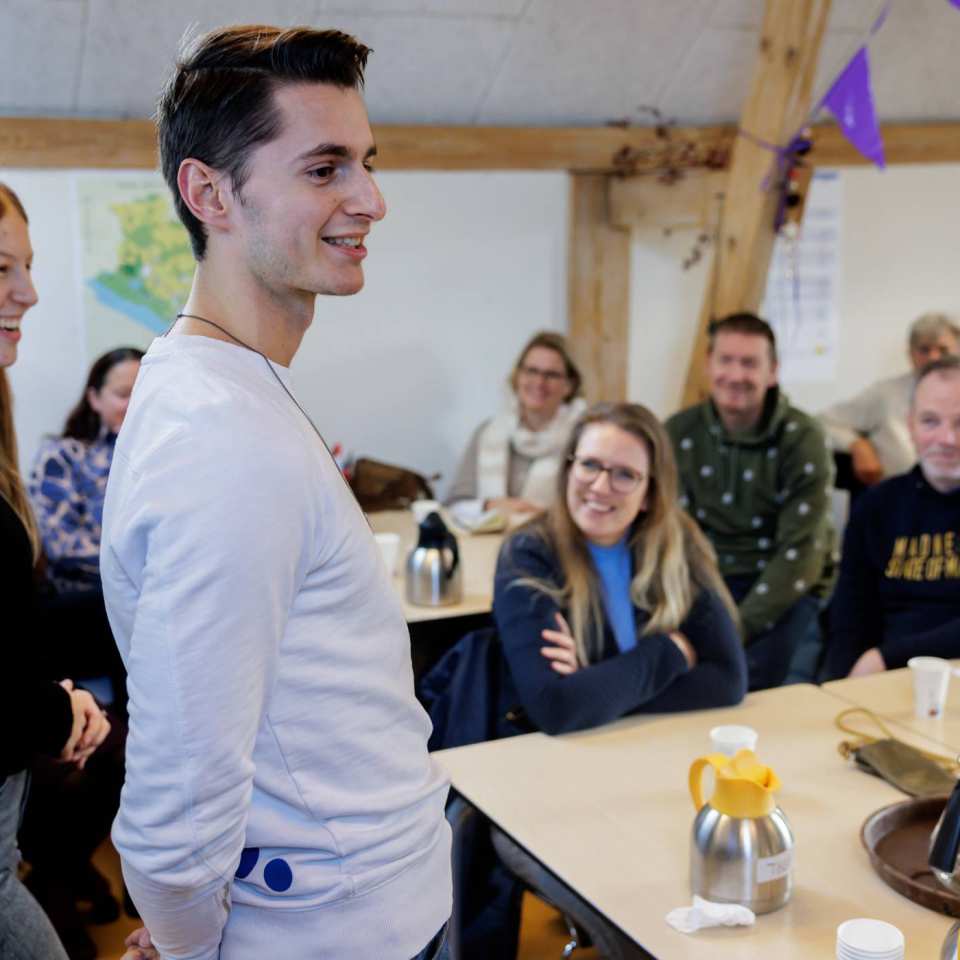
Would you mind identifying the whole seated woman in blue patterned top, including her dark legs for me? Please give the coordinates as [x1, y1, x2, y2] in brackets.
[20, 347, 143, 957]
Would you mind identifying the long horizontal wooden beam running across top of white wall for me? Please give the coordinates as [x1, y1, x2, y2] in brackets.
[0, 117, 960, 174]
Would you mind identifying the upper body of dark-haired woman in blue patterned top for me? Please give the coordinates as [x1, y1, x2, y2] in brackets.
[30, 347, 143, 594]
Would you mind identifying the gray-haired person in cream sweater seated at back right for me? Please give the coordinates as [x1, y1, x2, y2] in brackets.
[820, 313, 960, 487]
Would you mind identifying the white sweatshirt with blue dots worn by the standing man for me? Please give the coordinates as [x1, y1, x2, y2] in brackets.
[101, 336, 450, 960]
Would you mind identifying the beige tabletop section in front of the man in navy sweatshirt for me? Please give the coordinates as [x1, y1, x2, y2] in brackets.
[822, 660, 960, 751]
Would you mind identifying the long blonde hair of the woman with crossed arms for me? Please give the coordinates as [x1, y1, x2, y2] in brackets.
[508, 403, 739, 664]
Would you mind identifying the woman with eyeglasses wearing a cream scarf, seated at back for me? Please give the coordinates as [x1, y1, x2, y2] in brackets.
[446, 331, 586, 526]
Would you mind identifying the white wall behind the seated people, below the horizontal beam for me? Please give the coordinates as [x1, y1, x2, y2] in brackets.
[9, 158, 960, 491]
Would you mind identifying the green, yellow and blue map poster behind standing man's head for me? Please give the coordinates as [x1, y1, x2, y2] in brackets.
[76, 171, 194, 360]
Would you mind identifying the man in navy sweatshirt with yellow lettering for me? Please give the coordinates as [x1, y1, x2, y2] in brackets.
[827, 356, 960, 677]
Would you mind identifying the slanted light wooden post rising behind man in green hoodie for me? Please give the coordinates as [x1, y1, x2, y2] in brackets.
[683, 0, 830, 406]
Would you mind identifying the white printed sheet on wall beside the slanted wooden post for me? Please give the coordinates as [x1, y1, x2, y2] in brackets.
[761, 170, 843, 382]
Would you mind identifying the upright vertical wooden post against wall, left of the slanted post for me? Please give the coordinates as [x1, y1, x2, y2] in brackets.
[567, 173, 630, 403]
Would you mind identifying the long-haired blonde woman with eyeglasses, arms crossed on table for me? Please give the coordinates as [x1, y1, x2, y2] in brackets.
[493, 403, 747, 734]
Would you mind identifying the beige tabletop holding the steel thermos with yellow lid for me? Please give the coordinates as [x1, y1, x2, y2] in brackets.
[435, 685, 951, 960]
